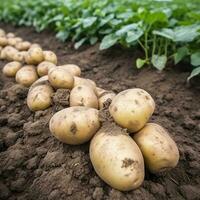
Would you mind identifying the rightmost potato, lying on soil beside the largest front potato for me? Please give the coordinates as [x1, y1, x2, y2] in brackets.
[133, 123, 179, 173]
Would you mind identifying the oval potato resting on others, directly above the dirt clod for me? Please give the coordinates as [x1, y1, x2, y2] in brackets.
[48, 67, 74, 89]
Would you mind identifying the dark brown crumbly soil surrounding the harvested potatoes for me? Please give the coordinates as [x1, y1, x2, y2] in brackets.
[0, 24, 200, 200]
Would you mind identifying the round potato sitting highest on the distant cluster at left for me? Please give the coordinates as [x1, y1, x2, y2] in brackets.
[25, 47, 44, 65]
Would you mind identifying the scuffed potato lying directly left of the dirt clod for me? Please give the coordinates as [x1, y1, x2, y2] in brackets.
[27, 85, 53, 111]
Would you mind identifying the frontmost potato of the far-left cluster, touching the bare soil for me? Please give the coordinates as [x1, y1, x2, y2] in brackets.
[15, 65, 38, 87]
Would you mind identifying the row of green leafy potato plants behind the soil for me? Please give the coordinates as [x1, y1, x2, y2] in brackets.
[0, 0, 200, 80]
